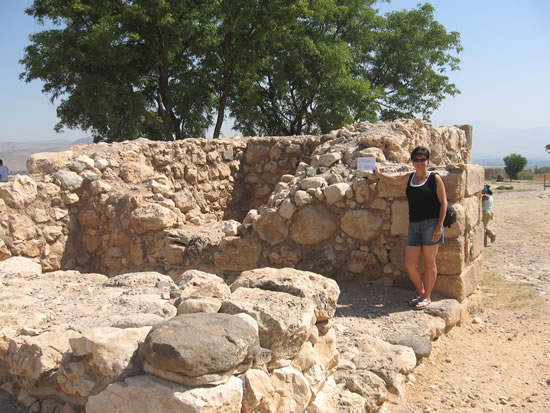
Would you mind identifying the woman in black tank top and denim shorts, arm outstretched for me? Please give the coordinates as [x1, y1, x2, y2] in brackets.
[373, 146, 447, 310]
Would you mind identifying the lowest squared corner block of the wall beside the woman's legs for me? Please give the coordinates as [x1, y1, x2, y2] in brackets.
[434, 255, 483, 302]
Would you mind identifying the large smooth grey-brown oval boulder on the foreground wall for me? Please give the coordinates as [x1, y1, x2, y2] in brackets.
[140, 313, 260, 386]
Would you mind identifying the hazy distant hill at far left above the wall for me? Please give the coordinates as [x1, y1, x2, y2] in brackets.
[0, 138, 92, 171]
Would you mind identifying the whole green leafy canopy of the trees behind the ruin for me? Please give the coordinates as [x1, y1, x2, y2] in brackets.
[21, 0, 462, 141]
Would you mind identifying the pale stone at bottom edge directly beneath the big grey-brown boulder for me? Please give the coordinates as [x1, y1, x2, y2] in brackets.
[86, 374, 243, 413]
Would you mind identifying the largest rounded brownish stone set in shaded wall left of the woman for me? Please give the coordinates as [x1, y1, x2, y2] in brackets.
[290, 205, 338, 245]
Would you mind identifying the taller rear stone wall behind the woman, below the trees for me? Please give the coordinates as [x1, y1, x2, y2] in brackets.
[0, 120, 483, 299]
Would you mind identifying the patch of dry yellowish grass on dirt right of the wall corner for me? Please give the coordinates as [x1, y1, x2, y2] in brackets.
[481, 272, 543, 311]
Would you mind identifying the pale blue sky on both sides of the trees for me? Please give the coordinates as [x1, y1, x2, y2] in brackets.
[0, 0, 550, 159]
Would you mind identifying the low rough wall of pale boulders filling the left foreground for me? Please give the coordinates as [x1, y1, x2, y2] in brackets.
[0, 258, 340, 413]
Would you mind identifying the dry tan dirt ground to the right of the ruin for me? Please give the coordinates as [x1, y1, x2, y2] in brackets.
[386, 182, 550, 413]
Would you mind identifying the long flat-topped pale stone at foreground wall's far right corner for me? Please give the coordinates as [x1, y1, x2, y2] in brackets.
[231, 268, 340, 322]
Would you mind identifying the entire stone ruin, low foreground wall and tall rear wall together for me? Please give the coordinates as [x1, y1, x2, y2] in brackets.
[0, 120, 483, 413]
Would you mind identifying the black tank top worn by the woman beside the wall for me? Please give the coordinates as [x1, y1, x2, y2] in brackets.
[406, 172, 441, 222]
